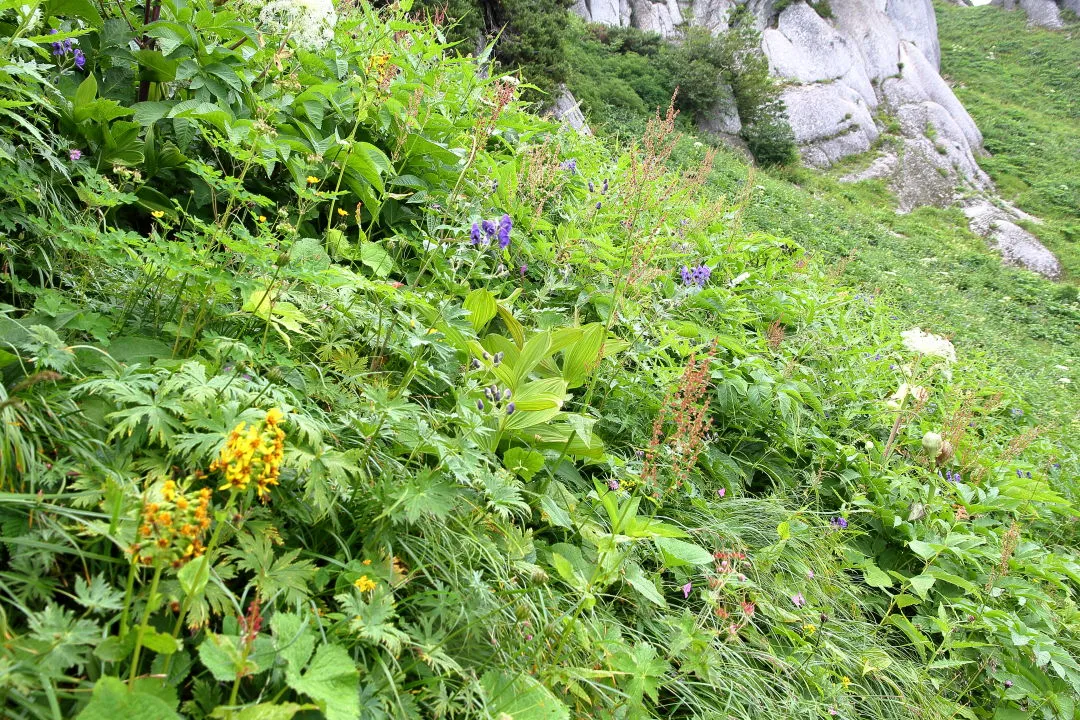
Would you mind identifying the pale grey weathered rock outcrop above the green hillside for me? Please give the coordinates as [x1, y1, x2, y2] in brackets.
[573, 0, 1062, 276]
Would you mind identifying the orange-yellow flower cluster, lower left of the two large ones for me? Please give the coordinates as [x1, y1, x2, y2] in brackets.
[132, 479, 211, 568]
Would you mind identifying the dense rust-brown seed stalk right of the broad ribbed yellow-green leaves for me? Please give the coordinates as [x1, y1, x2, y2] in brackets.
[642, 343, 716, 498]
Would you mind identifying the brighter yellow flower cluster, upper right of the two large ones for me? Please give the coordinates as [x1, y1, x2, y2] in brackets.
[210, 408, 285, 502]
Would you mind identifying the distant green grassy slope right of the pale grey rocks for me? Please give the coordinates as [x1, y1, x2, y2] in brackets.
[936, 3, 1080, 281]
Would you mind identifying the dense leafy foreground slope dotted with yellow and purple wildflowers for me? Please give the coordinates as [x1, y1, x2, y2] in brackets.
[0, 2, 1080, 720]
